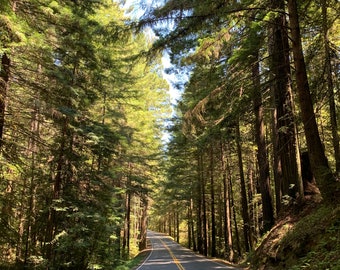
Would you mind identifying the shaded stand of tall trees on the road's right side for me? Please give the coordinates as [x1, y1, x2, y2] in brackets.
[145, 0, 340, 262]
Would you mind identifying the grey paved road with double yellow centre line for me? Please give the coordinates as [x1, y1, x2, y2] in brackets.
[137, 231, 240, 270]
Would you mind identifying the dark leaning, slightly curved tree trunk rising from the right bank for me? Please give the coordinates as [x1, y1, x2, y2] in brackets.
[288, 0, 339, 202]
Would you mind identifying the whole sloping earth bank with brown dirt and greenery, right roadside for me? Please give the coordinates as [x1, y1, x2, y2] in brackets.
[249, 198, 340, 270]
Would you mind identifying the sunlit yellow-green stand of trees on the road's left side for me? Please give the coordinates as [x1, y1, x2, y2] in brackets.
[0, 0, 169, 269]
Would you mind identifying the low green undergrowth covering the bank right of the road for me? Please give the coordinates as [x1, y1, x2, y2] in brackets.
[279, 206, 340, 269]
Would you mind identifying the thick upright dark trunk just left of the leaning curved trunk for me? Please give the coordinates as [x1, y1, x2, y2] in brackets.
[269, 0, 303, 198]
